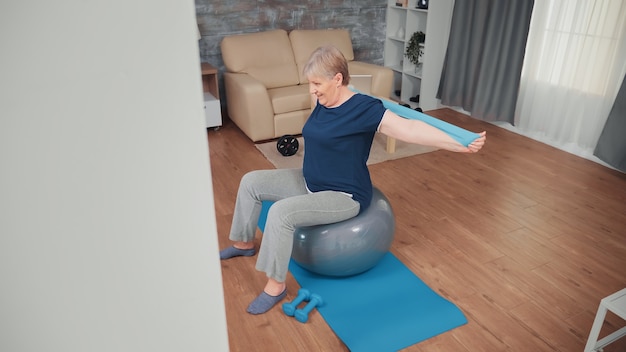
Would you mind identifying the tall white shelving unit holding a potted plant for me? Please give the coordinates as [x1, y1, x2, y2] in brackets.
[384, 0, 454, 110]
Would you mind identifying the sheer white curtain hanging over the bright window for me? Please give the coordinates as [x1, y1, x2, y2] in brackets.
[515, 0, 626, 157]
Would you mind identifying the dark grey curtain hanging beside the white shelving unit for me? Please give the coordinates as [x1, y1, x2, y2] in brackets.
[437, 0, 534, 124]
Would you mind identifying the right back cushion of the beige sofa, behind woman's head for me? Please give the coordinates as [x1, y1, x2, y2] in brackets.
[289, 29, 354, 83]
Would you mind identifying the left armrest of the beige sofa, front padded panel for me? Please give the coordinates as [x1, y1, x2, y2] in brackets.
[224, 72, 274, 142]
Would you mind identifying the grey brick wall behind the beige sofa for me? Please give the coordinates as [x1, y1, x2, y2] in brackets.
[195, 0, 387, 98]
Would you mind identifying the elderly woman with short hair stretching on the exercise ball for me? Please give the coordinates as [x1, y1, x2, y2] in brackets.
[220, 46, 486, 314]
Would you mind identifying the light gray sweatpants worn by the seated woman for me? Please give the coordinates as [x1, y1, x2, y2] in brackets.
[229, 169, 360, 282]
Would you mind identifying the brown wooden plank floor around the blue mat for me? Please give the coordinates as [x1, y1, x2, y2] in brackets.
[208, 109, 626, 352]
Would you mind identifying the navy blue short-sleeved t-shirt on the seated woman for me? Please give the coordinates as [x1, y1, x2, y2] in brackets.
[302, 94, 386, 211]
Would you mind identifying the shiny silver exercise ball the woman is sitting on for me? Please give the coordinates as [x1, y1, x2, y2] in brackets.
[291, 187, 396, 276]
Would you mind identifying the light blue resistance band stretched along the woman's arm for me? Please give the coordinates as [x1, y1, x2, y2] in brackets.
[350, 87, 480, 147]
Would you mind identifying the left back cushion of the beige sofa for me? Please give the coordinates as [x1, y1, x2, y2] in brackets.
[220, 29, 299, 88]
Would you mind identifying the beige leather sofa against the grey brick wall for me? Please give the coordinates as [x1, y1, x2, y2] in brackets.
[221, 29, 393, 142]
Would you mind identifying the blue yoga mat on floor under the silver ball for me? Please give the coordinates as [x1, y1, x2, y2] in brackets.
[258, 202, 467, 352]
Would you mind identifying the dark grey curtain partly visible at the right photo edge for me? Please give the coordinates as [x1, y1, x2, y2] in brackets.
[593, 77, 626, 172]
